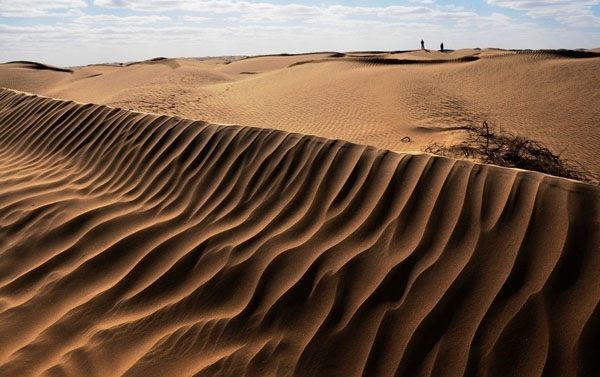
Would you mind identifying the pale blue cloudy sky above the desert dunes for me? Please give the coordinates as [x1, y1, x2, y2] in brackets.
[0, 0, 600, 66]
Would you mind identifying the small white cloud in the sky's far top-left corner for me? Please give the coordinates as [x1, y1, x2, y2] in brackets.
[0, 0, 87, 17]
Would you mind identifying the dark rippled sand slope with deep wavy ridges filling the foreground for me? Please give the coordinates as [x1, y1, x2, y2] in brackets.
[0, 90, 600, 377]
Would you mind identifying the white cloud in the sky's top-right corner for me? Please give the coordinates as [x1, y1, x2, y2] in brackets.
[487, 0, 600, 27]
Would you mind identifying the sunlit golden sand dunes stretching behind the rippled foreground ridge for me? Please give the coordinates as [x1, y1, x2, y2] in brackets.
[0, 49, 600, 174]
